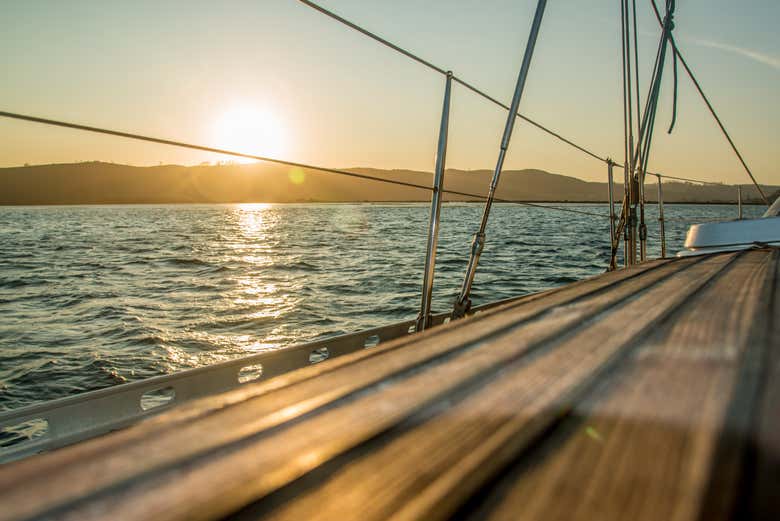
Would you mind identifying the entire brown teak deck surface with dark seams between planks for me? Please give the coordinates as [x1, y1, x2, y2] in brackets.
[0, 249, 780, 521]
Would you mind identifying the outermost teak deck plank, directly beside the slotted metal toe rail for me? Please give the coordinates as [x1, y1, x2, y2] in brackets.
[0, 261, 672, 519]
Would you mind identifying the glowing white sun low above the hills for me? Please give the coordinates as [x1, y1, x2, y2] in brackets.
[214, 104, 287, 163]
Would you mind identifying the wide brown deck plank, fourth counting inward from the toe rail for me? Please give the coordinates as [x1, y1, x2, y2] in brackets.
[464, 248, 773, 520]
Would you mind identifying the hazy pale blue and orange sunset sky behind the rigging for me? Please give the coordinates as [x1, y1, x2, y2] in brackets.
[0, 0, 780, 184]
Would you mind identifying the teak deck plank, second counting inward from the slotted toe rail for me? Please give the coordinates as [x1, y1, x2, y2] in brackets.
[3, 259, 704, 520]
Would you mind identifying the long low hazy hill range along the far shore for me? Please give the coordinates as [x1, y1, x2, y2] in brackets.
[0, 162, 780, 205]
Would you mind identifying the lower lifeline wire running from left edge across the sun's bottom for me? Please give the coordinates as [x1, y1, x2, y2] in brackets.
[0, 111, 604, 217]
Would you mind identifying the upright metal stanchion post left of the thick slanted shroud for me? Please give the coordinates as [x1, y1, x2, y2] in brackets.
[416, 71, 452, 331]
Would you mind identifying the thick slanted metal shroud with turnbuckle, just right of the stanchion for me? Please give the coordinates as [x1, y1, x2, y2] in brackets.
[452, 0, 547, 318]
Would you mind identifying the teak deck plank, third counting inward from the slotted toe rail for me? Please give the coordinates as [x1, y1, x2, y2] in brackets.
[235, 252, 728, 520]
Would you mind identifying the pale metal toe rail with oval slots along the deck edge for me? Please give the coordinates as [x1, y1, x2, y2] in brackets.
[0, 297, 525, 463]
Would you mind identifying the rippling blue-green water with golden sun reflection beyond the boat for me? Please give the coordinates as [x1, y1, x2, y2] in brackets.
[0, 204, 760, 408]
